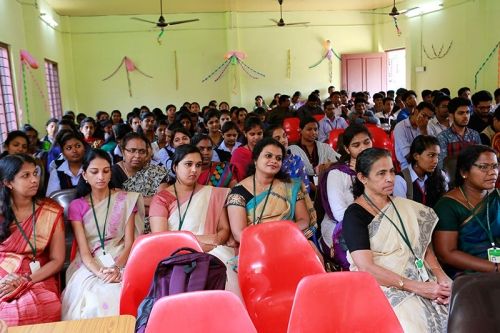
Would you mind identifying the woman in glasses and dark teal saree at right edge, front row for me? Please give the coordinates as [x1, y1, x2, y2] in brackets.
[433, 145, 500, 277]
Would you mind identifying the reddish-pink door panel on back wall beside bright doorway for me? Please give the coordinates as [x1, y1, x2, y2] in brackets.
[342, 52, 387, 95]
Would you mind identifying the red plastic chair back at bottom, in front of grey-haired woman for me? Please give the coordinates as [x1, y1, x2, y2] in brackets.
[288, 272, 403, 333]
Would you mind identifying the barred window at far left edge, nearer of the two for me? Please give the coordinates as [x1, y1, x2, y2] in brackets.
[0, 43, 17, 142]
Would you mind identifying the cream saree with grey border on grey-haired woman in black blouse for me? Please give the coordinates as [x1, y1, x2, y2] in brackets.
[347, 197, 448, 333]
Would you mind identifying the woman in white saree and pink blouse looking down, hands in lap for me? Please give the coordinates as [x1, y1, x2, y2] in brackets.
[62, 149, 144, 320]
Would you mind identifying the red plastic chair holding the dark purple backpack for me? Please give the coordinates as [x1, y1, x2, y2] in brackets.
[120, 231, 203, 316]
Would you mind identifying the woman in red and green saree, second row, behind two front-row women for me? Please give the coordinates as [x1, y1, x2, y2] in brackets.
[191, 134, 236, 188]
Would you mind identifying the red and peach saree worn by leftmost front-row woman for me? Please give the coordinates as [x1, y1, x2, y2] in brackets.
[0, 200, 64, 326]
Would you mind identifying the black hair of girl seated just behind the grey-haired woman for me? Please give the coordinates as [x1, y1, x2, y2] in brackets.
[406, 135, 446, 207]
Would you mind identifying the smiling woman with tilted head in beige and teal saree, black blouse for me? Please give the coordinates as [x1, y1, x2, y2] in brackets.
[226, 138, 316, 242]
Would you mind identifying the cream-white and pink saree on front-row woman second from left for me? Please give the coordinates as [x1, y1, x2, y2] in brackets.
[62, 191, 144, 320]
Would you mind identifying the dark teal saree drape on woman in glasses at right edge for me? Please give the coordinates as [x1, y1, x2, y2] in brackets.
[457, 189, 500, 260]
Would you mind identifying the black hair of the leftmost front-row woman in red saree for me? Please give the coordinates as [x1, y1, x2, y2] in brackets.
[0, 154, 37, 243]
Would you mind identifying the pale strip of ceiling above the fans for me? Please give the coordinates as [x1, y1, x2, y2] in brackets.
[46, 0, 404, 16]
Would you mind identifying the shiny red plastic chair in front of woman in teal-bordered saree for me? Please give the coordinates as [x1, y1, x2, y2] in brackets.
[238, 221, 325, 333]
